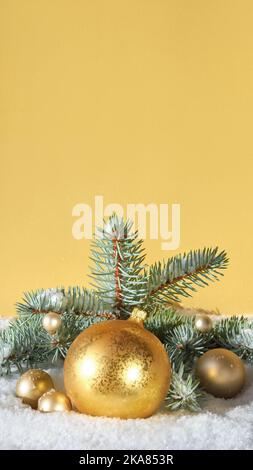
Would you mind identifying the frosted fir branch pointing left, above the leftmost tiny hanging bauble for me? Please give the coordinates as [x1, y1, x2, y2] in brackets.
[16, 287, 110, 317]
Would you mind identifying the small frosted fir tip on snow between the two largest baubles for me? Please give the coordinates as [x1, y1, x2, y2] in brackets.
[165, 363, 204, 412]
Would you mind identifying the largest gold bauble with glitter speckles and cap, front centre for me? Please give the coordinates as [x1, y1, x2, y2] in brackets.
[64, 309, 170, 418]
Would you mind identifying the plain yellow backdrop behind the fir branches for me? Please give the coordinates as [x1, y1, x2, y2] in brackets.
[0, 0, 253, 315]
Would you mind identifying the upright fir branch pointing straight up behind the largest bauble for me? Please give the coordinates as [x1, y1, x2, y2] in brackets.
[90, 214, 147, 318]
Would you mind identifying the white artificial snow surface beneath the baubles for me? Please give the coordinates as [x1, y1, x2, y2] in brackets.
[0, 323, 253, 450]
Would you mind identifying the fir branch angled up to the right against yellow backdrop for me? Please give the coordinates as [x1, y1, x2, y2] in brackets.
[145, 247, 228, 304]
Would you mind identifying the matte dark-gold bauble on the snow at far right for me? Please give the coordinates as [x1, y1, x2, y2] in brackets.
[196, 348, 245, 398]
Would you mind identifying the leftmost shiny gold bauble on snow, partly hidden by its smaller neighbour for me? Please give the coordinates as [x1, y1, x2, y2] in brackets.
[16, 369, 54, 408]
